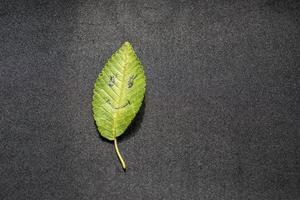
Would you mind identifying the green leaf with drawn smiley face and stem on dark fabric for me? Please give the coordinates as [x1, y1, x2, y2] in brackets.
[92, 42, 146, 170]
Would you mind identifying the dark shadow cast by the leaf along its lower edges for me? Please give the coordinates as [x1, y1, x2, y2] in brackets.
[94, 98, 146, 143]
